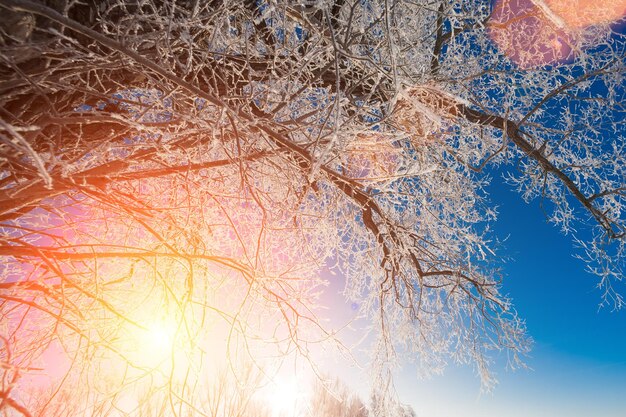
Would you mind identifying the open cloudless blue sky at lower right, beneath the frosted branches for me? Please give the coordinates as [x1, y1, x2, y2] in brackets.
[397, 171, 626, 417]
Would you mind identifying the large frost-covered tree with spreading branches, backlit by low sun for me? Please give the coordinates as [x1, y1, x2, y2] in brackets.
[0, 0, 626, 416]
